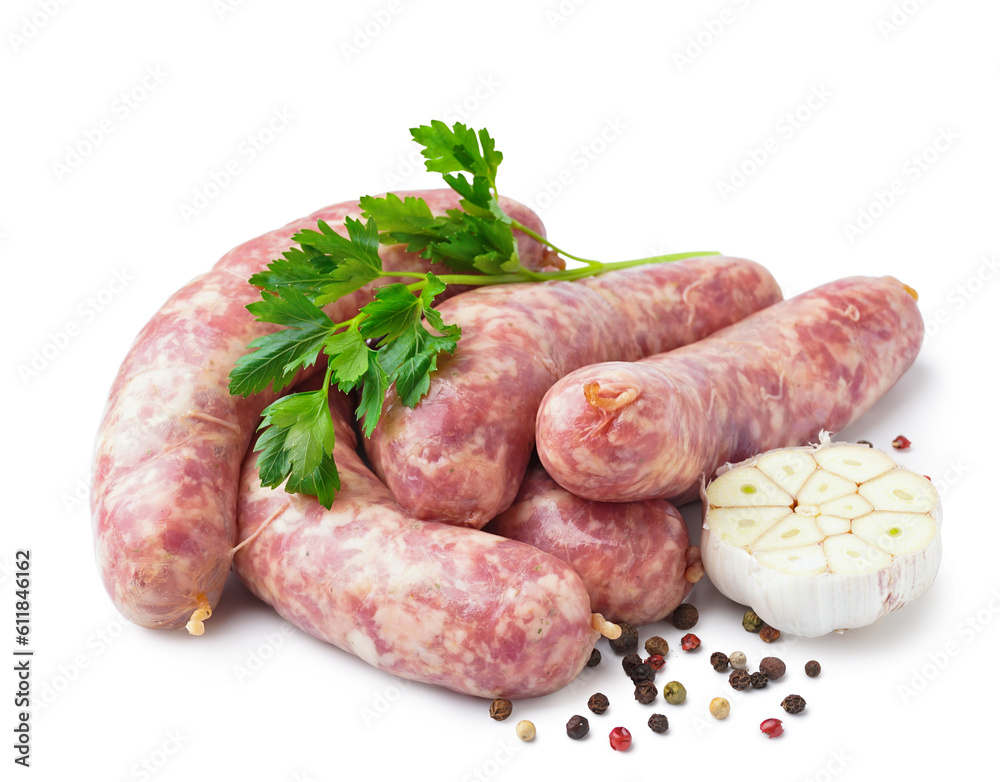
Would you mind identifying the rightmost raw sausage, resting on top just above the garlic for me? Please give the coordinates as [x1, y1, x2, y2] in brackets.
[536, 277, 923, 503]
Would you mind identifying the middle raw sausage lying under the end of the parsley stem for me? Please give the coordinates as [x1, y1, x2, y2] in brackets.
[365, 257, 781, 528]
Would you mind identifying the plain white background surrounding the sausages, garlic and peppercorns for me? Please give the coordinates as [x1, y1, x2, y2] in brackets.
[0, 0, 1000, 782]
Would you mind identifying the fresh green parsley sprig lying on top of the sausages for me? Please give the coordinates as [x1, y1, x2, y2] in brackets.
[229, 120, 710, 508]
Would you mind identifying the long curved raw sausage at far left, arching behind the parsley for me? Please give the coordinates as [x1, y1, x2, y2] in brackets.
[91, 190, 548, 634]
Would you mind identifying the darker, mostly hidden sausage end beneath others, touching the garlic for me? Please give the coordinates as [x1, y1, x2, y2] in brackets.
[483, 461, 704, 627]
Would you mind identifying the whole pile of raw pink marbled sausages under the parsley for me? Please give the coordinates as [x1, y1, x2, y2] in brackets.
[93, 191, 922, 698]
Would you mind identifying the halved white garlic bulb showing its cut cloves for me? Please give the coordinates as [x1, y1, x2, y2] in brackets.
[701, 432, 942, 638]
